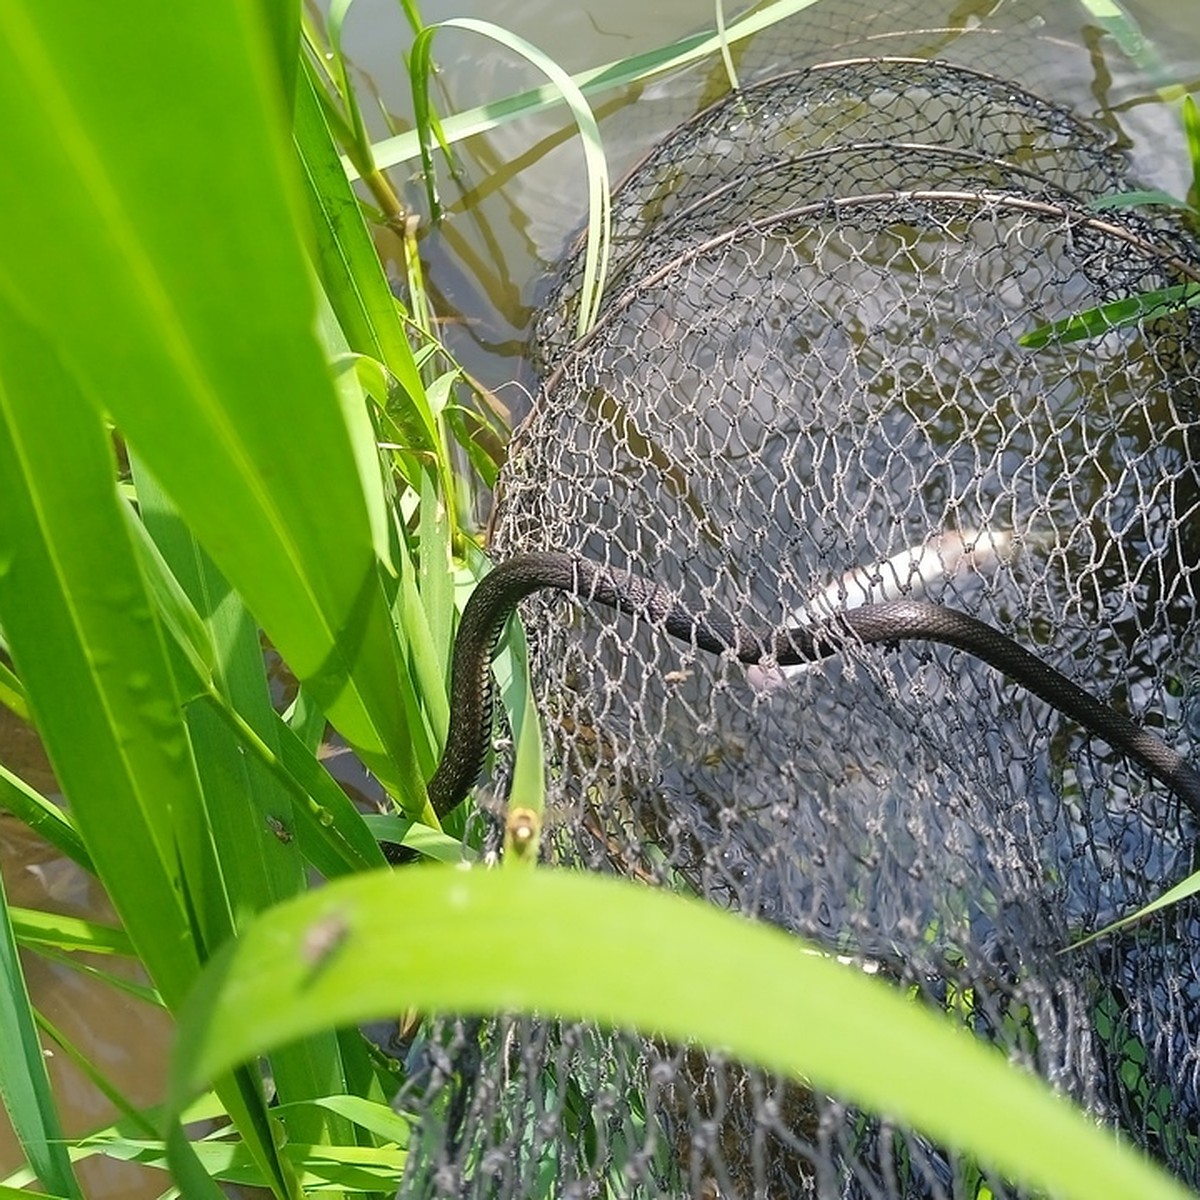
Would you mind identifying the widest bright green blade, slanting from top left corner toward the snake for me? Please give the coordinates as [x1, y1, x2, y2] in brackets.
[0, 0, 426, 812]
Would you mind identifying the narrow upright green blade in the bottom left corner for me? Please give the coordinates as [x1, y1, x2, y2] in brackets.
[0, 881, 83, 1200]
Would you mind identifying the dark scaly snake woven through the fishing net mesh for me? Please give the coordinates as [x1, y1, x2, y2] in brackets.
[427, 551, 1200, 817]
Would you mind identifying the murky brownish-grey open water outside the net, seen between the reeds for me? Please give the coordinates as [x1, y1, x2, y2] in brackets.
[0, 0, 1200, 1198]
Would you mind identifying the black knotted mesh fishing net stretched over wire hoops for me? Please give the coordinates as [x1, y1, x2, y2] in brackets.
[402, 51, 1200, 1198]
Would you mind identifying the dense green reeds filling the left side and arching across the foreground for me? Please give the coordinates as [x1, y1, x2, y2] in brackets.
[0, 0, 1182, 1198]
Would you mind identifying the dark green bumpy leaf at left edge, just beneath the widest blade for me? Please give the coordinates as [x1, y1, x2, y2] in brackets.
[0, 297, 199, 1002]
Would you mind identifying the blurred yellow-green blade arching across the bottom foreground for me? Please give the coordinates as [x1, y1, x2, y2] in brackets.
[170, 866, 1187, 1200]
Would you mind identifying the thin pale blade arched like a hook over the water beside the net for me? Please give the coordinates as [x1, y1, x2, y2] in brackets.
[409, 17, 610, 337]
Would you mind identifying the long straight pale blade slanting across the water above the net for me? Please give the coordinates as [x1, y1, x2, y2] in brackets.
[369, 0, 817, 180]
